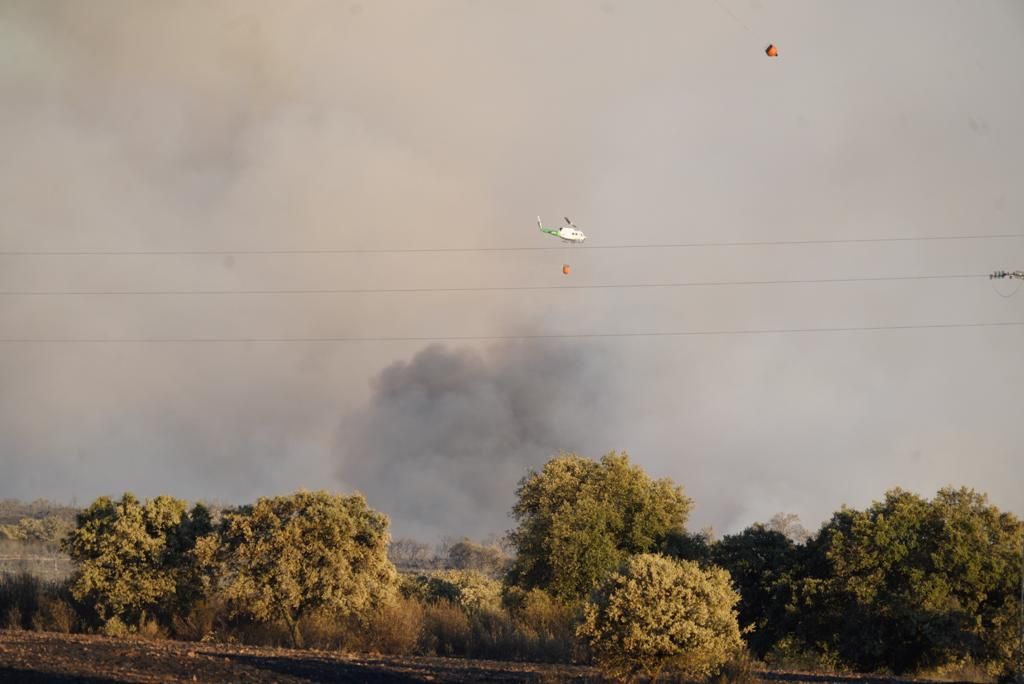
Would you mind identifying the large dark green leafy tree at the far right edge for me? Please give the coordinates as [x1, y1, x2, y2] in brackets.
[796, 488, 1024, 675]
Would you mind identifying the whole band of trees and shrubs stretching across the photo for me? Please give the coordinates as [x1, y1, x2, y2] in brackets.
[0, 453, 1024, 679]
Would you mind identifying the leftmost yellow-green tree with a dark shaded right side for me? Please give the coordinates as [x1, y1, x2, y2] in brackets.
[63, 493, 210, 626]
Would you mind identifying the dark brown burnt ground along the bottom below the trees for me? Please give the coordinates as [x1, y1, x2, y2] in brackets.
[0, 630, 991, 684]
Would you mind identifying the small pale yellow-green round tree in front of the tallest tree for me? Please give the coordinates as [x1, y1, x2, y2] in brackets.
[578, 554, 742, 681]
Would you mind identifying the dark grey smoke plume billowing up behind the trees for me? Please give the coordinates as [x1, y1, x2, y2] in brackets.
[340, 344, 615, 539]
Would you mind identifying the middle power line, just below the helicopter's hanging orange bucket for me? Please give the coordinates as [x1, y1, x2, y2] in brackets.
[0, 273, 988, 297]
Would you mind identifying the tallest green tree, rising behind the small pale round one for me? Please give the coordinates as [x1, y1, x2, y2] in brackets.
[509, 452, 692, 600]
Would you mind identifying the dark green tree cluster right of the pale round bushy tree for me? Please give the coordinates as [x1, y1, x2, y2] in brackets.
[680, 488, 1024, 676]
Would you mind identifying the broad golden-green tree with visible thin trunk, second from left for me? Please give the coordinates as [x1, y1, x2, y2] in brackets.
[219, 491, 397, 647]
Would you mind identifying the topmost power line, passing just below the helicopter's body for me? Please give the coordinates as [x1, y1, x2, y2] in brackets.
[0, 232, 1024, 257]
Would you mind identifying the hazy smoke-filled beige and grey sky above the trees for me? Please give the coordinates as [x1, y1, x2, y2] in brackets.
[0, 0, 1024, 539]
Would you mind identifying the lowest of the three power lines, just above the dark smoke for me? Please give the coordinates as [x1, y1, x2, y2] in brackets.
[0, 320, 1024, 344]
